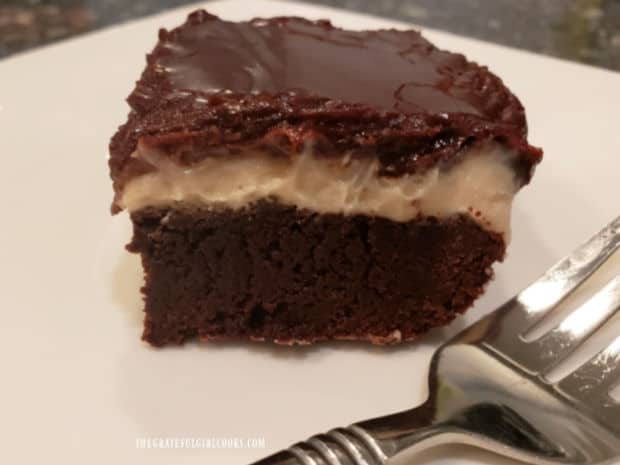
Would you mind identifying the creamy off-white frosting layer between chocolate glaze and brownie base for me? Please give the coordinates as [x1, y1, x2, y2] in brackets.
[120, 143, 518, 233]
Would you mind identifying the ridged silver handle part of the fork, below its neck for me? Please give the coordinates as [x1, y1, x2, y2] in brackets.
[252, 405, 440, 465]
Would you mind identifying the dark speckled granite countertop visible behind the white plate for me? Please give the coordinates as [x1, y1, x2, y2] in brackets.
[0, 0, 620, 70]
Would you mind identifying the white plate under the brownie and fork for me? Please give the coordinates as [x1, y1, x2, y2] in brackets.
[0, 0, 620, 465]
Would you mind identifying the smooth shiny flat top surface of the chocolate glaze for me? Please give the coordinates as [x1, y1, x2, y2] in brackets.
[163, 17, 493, 116]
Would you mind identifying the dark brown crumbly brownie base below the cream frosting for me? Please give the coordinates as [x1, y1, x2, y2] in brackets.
[128, 202, 505, 346]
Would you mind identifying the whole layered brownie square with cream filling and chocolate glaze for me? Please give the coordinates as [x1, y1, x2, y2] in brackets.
[109, 10, 541, 346]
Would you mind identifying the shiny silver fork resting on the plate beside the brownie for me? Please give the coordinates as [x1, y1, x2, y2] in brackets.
[249, 217, 620, 465]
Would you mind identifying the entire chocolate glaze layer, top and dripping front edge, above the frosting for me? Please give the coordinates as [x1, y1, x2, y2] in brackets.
[110, 11, 541, 212]
